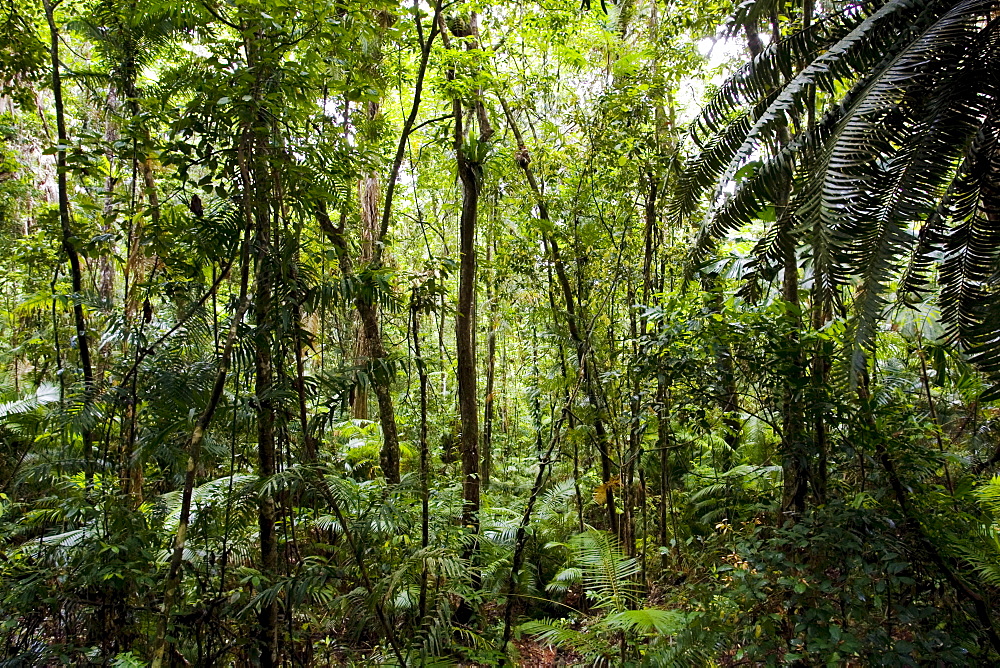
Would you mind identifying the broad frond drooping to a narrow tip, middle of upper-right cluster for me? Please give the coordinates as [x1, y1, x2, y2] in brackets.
[822, 0, 1000, 366]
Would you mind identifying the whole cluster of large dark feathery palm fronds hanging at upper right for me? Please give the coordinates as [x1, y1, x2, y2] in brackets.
[673, 0, 1000, 373]
